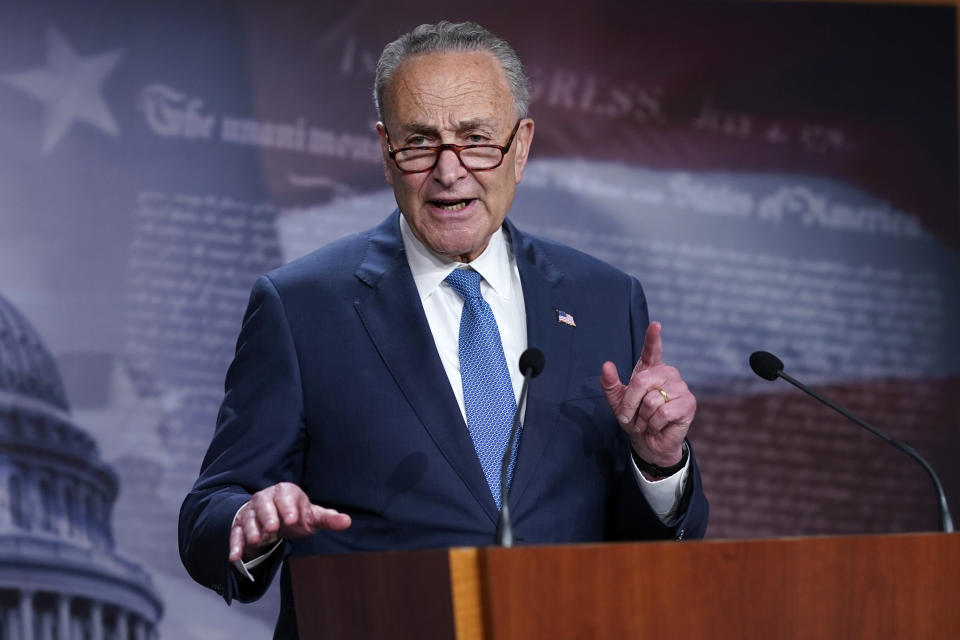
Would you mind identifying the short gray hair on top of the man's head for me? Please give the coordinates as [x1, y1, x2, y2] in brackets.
[373, 20, 530, 121]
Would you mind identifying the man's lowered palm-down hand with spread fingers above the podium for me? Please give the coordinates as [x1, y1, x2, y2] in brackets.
[228, 482, 350, 562]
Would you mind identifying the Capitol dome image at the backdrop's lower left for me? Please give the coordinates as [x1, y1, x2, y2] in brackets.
[0, 296, 163, 640]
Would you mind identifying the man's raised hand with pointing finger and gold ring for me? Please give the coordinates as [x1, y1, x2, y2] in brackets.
[600, 322, 697, 467]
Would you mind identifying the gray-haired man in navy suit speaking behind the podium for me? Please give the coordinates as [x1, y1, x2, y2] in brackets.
[180, 18, 707, 637]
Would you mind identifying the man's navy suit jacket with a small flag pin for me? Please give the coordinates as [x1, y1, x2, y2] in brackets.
[179, 211, 707, 637]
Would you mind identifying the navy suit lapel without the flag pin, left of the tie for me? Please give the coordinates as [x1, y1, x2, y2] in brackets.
[354, 211, 498, 522]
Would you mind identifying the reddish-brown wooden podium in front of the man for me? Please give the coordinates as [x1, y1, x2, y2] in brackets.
[291, 533, 960, 640]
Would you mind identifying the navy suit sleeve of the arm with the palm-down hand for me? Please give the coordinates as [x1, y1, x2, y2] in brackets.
[179, 276, 305, 603]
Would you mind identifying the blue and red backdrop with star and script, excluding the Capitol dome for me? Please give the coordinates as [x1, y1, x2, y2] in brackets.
[0, 0, 960, 638]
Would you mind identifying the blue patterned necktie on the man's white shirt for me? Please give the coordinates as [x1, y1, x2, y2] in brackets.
[444, 269, 519, 509]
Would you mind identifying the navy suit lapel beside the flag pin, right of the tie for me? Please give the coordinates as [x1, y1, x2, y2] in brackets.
[505, 221, 576, 505]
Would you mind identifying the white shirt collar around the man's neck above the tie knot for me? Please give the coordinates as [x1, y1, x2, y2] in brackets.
[400, 214, 513, 300]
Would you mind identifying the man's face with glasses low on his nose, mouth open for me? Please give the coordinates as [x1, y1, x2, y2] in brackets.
[377, 51, 533, 262]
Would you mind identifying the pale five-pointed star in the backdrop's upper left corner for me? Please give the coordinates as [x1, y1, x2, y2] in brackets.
[3, 27, 123, 153]
